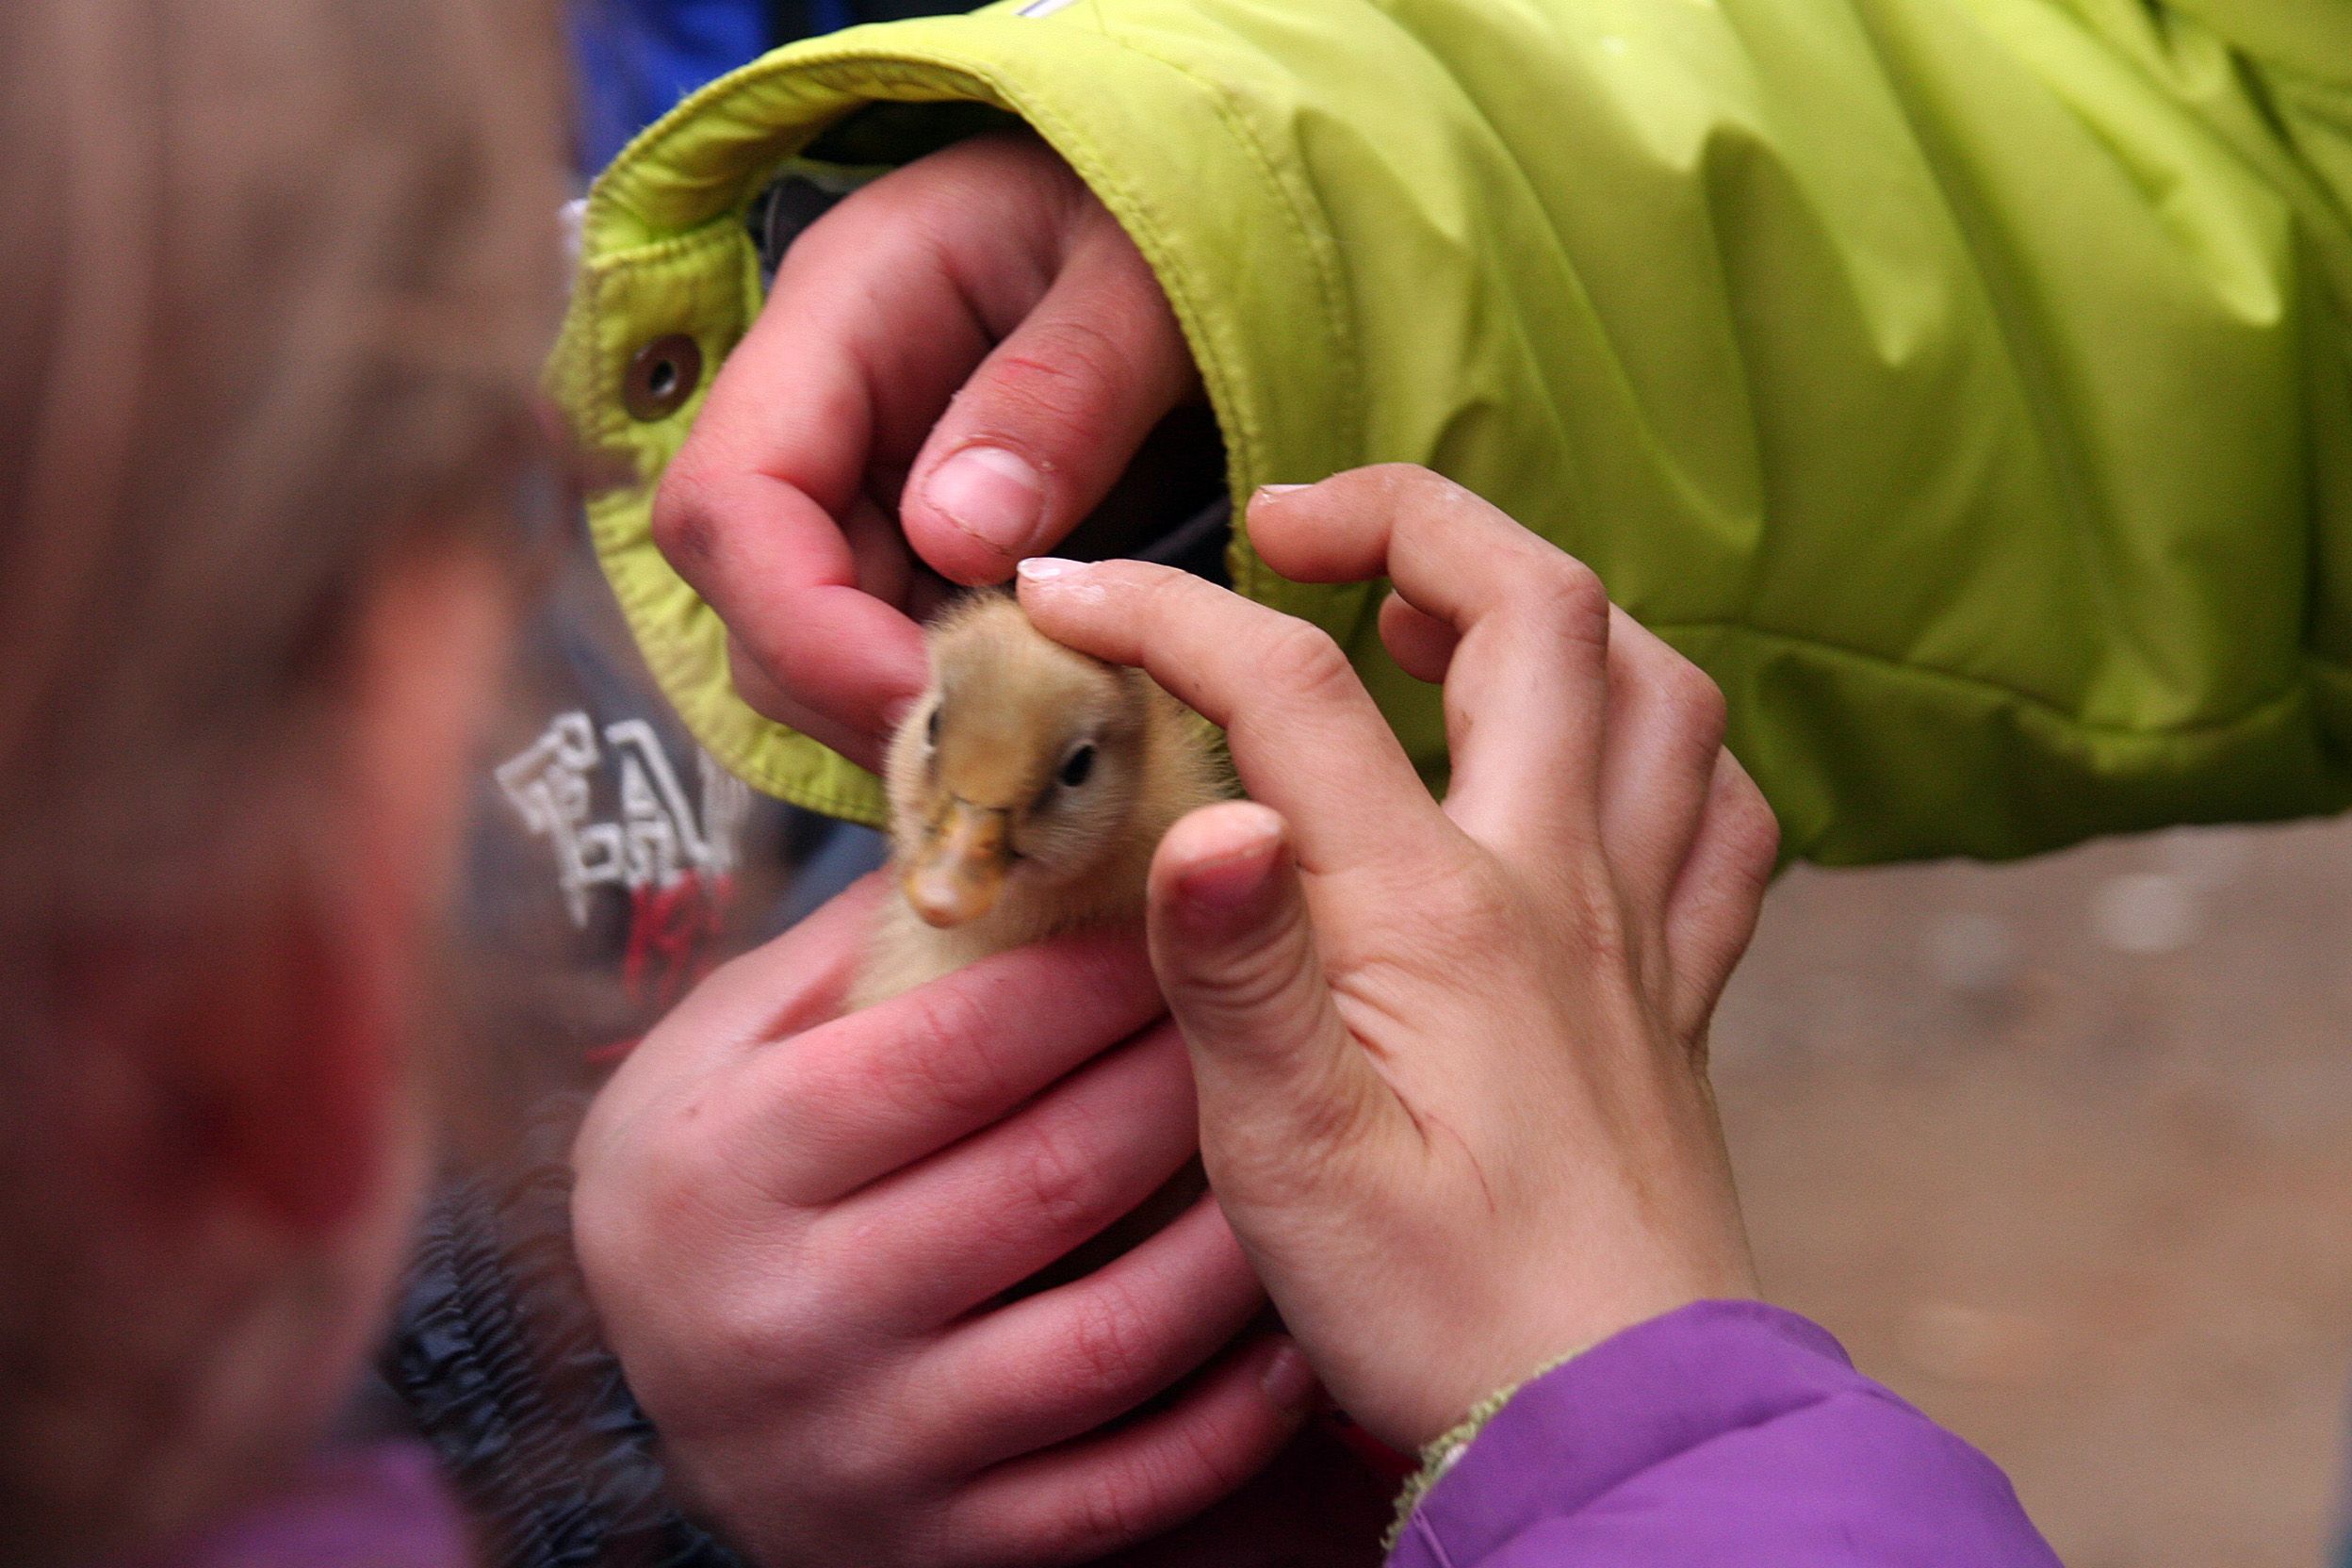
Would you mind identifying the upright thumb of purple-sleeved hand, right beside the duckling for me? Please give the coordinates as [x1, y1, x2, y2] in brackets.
[1151, 802, 1393, 1184]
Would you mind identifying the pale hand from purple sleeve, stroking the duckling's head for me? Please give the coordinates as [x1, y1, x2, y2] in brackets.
[1021, 467, 1775, 1446]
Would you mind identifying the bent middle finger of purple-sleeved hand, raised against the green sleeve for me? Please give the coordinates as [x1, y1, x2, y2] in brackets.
[1249, 463, 1611, 846]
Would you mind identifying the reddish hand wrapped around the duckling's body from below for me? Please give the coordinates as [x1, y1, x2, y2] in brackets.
[572, 879, 1313, 1568]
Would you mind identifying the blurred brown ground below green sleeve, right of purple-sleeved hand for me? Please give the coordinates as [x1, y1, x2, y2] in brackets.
[1715, 821, 2352, 1568]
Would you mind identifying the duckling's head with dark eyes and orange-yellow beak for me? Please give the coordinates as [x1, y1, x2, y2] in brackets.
[887, 595, 1174, 926]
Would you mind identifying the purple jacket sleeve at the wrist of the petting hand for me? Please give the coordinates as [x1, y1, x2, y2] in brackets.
[1390, 1302, 2058, 1568]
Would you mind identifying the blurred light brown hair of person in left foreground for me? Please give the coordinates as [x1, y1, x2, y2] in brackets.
[0, 0, 563, 1561]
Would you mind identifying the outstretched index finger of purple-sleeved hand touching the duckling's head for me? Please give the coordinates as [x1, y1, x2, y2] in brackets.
[1021, 560, 1445, 874]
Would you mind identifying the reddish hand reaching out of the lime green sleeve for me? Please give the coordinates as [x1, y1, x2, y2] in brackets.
[654, 134, 1200, 766]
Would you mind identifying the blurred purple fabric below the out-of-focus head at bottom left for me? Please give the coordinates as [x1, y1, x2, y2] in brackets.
[113, 1444, 475, 1568]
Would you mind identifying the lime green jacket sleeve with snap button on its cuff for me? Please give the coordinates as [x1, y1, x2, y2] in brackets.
[553, 0, 2352, 863]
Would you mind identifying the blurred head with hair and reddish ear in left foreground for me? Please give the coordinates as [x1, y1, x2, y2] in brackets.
[0, 0, 560, 1561]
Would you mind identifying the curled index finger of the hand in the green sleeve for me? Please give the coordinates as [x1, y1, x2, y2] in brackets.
[654, 139, 1075, 766]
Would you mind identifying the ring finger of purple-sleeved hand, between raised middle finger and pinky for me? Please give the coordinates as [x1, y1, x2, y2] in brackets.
[1602, 612, 1724, 928]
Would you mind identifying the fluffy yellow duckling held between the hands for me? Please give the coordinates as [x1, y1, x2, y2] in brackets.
[849, 593, 1233, 1006]
